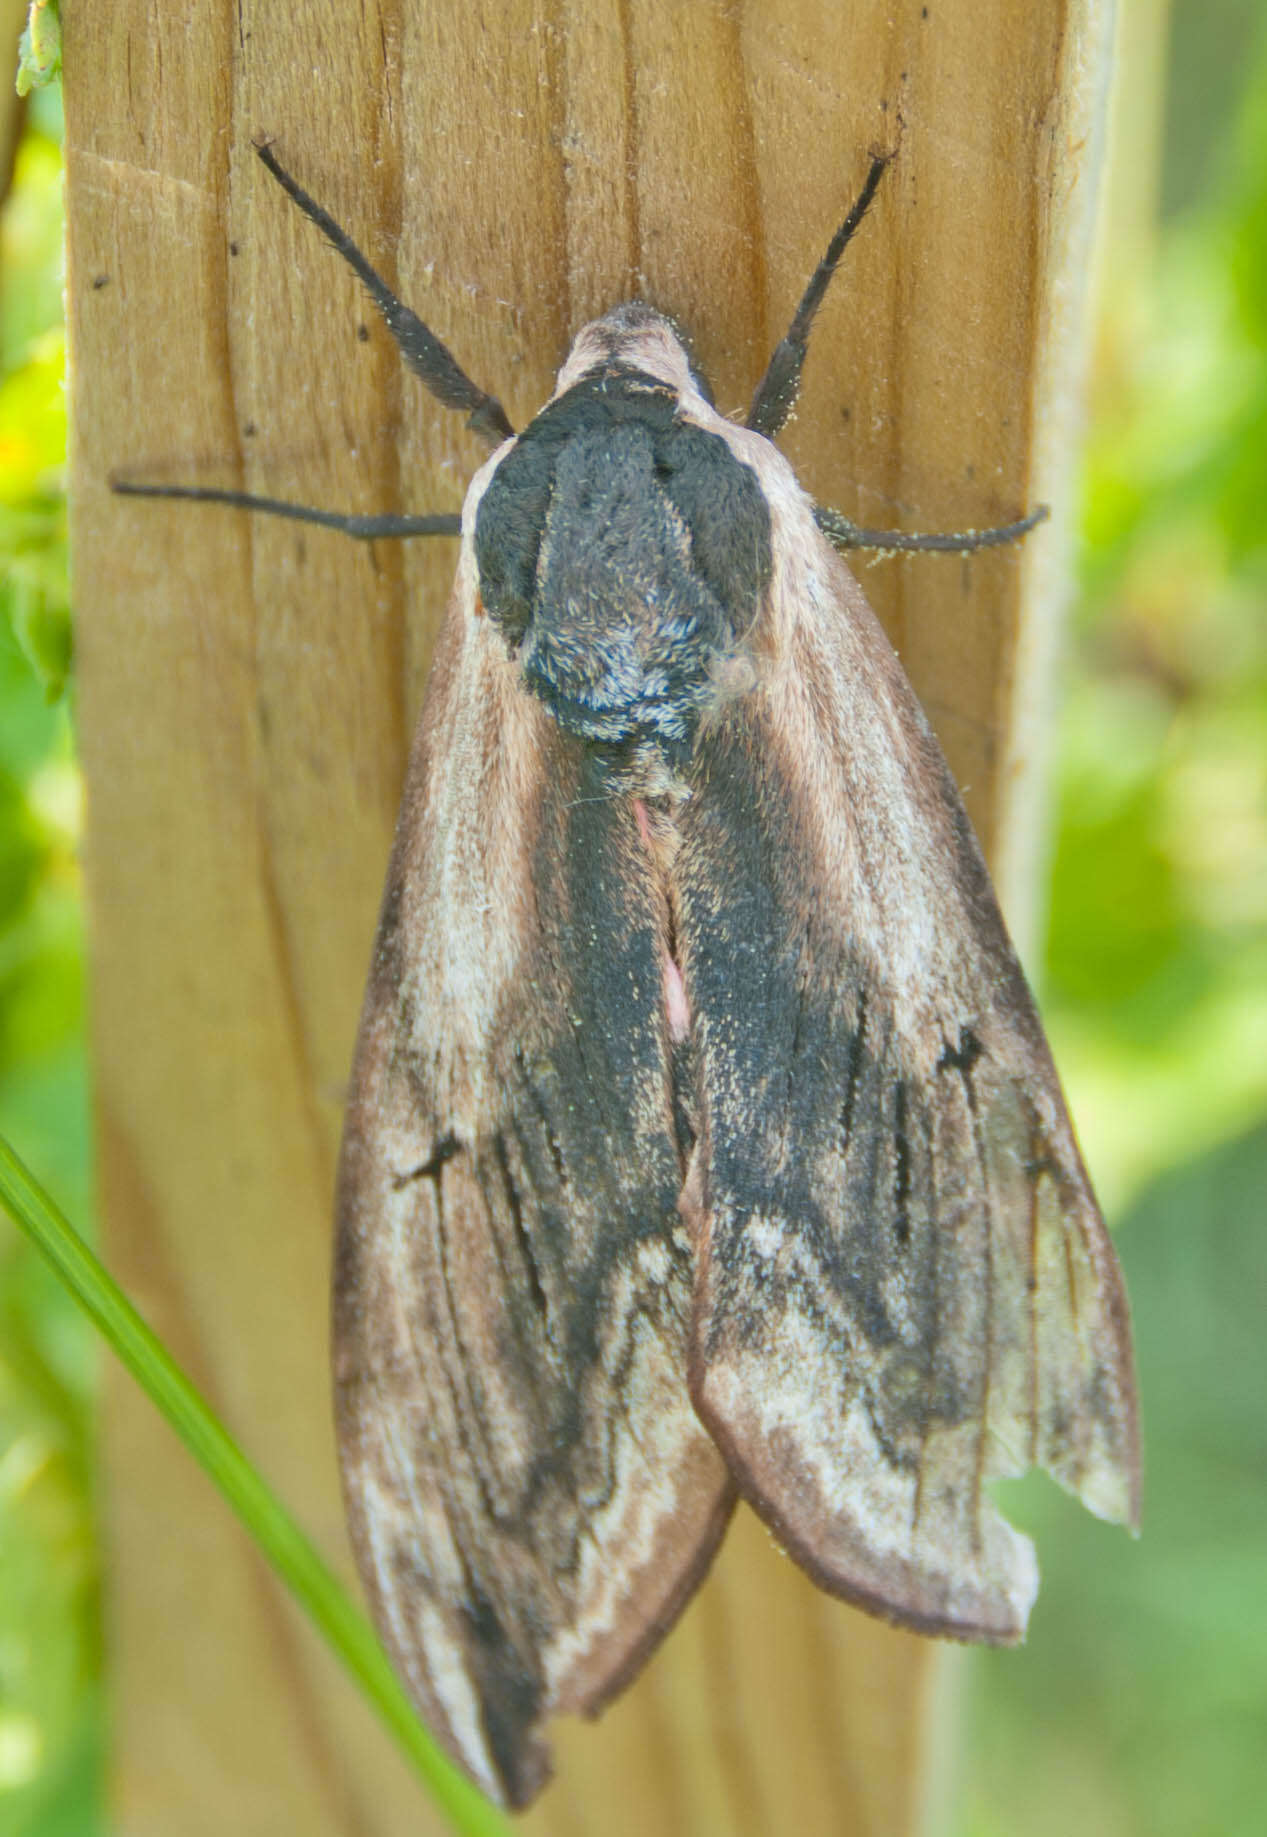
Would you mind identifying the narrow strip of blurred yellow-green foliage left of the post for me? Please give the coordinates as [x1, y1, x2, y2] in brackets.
[0, 71, 101, 1837]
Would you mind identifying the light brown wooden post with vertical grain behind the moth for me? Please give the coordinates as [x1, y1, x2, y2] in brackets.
[66, 0, 1105, 1837]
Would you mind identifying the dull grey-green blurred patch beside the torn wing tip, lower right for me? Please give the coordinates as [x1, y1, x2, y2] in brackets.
[960, 1128, 1267, 1837]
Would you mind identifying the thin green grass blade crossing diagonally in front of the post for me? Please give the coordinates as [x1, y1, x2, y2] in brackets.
[0, 1137, 509, 1837]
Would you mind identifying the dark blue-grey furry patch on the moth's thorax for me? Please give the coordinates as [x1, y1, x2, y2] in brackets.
[476, 364, 771, 762]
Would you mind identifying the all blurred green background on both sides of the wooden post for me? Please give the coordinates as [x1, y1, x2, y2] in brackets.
[0, 0, 1267, 1837]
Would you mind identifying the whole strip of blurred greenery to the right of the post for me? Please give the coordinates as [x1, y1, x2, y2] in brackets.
[960, 0, 1267, 1837]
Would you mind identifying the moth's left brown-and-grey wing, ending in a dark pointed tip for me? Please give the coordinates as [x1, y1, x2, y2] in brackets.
[334, 576, 733, 1806]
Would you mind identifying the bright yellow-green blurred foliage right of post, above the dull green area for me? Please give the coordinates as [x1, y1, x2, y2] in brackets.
[1047, 7, 1267, 1211]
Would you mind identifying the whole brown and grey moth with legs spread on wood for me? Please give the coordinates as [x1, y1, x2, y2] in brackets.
[119, 143, 1138, 1808]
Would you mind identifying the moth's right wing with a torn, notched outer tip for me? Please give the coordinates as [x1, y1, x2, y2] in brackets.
[678, 470, 1138, 1640]
